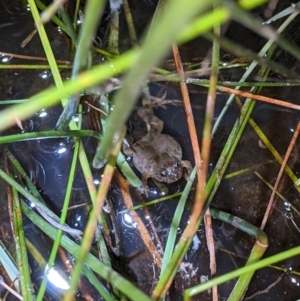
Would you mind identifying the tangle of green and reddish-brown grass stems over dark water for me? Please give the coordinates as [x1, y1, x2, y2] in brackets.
[0, 0, 300, 301]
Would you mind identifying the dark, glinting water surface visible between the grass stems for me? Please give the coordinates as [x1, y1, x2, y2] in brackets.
[0, 0, 300, 301]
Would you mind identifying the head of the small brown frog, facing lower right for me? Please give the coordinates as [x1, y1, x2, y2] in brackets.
[157, 154, 182, 183]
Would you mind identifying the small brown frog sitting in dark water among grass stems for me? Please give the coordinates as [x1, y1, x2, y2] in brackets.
[124, 107, 192, 196]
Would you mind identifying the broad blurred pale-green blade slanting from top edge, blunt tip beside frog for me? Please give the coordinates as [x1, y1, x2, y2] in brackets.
[93, 0, 212, 168]
